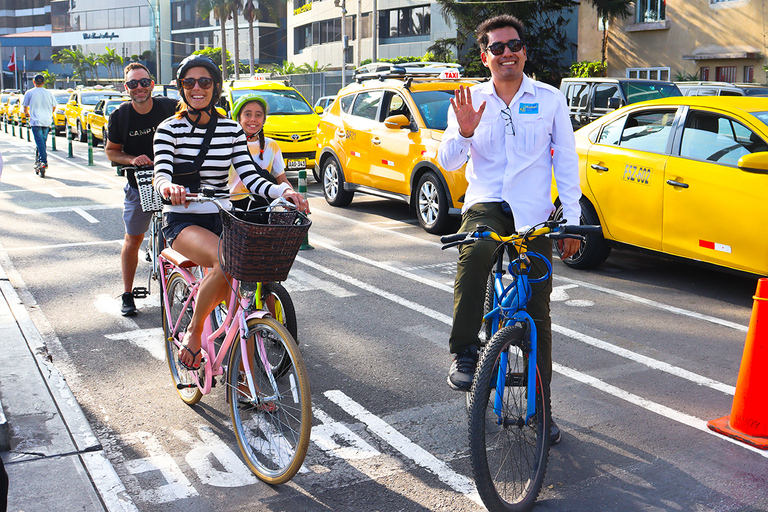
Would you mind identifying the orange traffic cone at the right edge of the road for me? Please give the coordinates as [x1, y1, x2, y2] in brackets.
[707, 278, 768, 450]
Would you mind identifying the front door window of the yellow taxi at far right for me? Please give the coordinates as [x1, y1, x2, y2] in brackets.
[680, 111, 768, 165]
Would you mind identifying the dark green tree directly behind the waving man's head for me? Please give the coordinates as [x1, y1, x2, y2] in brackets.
[428, 0, 576, 84]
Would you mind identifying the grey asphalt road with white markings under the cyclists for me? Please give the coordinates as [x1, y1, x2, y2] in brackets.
[0, 127, 768, 512]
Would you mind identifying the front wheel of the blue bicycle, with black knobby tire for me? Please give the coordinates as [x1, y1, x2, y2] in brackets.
[469, 324, 552, 512]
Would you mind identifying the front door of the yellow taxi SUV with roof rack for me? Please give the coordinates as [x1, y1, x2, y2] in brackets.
[370, 91, 421, 195]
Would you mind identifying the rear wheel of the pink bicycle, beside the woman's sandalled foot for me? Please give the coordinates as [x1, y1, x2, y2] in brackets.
[160, 272, 204, 405]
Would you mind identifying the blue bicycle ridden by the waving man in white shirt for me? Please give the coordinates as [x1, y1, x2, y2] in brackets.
[441, 221, 600, 512]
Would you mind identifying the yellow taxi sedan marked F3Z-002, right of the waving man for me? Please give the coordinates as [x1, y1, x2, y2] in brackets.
[555, 96, 768, 275]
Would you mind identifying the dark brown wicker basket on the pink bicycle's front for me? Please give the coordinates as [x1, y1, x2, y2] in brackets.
[219, 210, 312, 282]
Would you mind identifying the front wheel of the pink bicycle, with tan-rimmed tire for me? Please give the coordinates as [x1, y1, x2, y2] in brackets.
[227, 317, 312, 485]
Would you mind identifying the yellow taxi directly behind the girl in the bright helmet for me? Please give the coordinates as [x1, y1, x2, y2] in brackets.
[219, 77, 322, 178]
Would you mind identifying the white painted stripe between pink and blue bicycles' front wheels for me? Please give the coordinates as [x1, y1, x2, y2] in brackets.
[323, 390, 483, 505]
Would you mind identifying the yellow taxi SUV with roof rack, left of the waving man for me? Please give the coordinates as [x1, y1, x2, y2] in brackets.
[316, 63, 478, 233]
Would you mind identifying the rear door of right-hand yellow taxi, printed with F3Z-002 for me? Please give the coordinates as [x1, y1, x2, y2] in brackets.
[586, 109, 675, 250]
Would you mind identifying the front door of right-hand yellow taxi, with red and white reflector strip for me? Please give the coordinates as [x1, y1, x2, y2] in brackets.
[663, 110, 768, 274]
